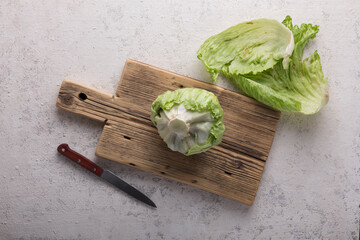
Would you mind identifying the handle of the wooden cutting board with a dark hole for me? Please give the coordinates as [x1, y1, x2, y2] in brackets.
[56, 80, 121, 122]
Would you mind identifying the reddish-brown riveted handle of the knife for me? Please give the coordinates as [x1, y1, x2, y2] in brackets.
[58, 143, 104, 177]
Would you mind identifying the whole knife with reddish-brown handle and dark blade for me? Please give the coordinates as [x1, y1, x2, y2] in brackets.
[57, 143, 156, 208]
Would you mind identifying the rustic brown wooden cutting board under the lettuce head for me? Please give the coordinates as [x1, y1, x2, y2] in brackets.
[56, 60, 280, 205]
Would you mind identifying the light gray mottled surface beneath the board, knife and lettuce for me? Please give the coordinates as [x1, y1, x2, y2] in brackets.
[0, 0, 360, 239]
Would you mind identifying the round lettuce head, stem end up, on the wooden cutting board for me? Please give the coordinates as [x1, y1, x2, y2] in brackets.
[151, 88, 225, 156]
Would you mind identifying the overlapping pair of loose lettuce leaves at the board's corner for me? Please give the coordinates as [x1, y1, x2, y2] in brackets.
[197, 16, 329, 114]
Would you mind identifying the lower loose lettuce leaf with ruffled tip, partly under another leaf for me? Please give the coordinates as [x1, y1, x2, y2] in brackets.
[198, 16, 329, 114]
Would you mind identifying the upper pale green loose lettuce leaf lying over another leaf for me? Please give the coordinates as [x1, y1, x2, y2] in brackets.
[197, 18, 294, 81]
